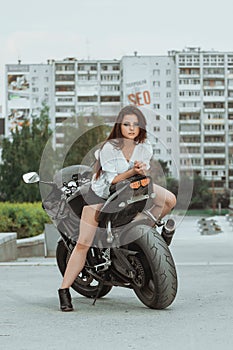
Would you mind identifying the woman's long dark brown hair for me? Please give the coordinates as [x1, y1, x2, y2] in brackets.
[95, 105, 147, 179]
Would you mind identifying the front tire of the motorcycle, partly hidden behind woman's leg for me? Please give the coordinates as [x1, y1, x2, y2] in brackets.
[56, 240, 112, 298]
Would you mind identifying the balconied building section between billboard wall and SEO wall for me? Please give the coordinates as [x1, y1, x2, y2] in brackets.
[50, 58, 121, 146]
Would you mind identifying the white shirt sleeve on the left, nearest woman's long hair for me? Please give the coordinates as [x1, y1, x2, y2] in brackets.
[100, 142, 118, 184]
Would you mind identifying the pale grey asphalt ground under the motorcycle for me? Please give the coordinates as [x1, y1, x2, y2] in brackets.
[0, 217, 233, 350]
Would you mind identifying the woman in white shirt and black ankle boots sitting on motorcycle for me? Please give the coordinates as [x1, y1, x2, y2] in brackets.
[58, 106, 176, 311]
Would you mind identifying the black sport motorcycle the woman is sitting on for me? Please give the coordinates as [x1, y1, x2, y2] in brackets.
[23, 165, 177, 309]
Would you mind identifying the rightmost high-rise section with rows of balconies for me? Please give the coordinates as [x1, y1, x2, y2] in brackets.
[169, 48, 233, 190]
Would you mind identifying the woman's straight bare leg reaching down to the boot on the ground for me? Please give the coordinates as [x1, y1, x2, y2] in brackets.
[61, 204, 102, 289]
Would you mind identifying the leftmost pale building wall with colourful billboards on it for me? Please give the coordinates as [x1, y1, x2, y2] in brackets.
[4, 61, 53, 136]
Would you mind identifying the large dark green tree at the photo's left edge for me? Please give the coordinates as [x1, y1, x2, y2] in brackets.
[0, 105, 52, 202]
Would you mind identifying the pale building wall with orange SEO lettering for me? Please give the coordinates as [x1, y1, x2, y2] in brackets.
[121, 53, 179, 178]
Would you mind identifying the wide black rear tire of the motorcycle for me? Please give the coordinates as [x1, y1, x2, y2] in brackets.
[128, 225, 177, 309]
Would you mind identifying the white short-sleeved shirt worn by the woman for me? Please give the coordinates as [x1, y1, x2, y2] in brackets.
[91, 140, 153, 198]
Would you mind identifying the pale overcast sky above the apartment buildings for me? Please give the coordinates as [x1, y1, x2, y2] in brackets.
[0, 0, 233, 104]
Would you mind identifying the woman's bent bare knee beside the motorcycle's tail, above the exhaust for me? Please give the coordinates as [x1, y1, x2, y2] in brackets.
[151, 184, 176, 219]
